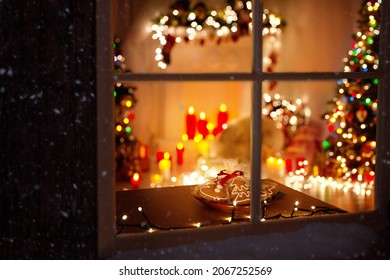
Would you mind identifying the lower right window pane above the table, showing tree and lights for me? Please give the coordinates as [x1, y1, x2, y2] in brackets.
[263, 79, 378, 212]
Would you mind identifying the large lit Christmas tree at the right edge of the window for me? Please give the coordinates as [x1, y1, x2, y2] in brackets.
[323, 0, 381, 182]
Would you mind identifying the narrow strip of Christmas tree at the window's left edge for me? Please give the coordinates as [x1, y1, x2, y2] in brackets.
[114, 39, 145, 179]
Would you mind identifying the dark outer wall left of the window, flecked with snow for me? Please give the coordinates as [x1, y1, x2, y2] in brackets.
[0, 0, 97, 259]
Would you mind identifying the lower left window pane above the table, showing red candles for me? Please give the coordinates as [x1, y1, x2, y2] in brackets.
[115, 82, 251, 189]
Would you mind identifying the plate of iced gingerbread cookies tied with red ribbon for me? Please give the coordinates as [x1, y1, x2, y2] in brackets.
[193, 170, 279, 212]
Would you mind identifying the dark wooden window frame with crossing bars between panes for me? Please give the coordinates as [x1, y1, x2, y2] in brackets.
[96, 0, 390, 258]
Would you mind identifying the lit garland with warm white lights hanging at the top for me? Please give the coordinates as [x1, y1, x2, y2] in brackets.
[151, 0, 285, 69]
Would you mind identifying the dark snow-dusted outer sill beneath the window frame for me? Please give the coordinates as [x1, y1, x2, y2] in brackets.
[112, 211, 390, 259]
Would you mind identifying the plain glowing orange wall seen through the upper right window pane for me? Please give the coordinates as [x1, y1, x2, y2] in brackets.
[264, 0, 362, 72]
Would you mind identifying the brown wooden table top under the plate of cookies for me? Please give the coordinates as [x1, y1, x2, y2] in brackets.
[116, 179, 345, 233]
